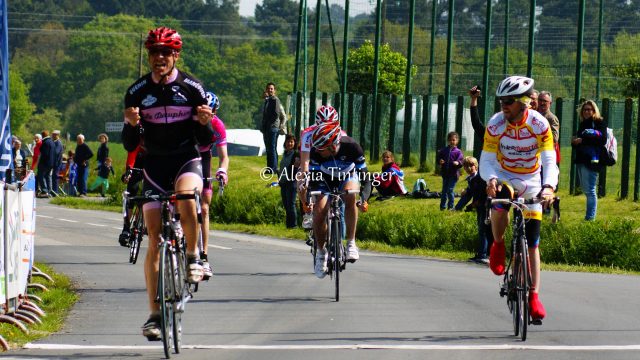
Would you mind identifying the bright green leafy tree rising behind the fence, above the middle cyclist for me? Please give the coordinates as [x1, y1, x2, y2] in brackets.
[347, 41, 417, 94]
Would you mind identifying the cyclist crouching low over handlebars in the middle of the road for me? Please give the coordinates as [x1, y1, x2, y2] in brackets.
[309, 121, 371, 279]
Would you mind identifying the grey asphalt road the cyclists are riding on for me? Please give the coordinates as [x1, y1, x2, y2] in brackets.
[3, 200, 640, 360]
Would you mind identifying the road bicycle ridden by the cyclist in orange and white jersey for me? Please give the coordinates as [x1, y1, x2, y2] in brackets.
[486, 193, 559, 341]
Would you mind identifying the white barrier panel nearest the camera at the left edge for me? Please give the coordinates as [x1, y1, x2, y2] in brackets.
[4, 184, 19, 305]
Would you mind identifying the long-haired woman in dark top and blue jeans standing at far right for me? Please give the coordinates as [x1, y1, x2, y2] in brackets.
[571, 100, 607, 221]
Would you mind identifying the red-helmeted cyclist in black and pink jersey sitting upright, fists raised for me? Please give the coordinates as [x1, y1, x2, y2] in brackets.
[122, 27, 213, 340]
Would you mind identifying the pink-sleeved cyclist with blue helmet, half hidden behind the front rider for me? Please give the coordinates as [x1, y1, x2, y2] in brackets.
[199, 91, 229, 280]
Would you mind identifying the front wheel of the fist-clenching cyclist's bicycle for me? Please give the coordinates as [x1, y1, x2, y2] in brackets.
[158, 243, 174, 359]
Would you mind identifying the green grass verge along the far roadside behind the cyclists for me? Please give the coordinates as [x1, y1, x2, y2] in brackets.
[53, 150, 640, 273]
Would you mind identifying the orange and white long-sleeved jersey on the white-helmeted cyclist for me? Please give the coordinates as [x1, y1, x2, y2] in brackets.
[480, 110, 559, 188]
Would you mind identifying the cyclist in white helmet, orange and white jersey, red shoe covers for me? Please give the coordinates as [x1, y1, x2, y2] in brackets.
[480, 76, 559, 320]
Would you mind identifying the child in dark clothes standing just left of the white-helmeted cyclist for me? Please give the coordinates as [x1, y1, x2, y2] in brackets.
[455, 156, 493, 264]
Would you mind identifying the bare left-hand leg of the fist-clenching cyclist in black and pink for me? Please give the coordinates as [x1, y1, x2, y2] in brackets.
[144, 207, 162, 313]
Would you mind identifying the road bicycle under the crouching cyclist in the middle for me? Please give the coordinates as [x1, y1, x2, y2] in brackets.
[310, 188, 360, 302]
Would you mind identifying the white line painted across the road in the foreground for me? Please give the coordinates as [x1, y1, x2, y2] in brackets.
[24, 343, 640, 351]
